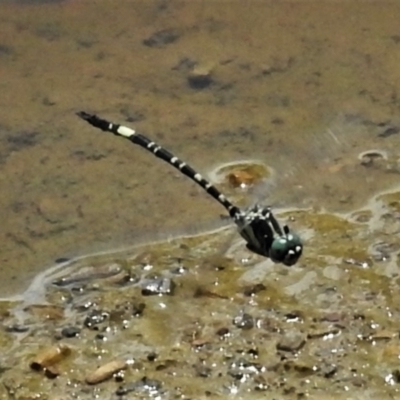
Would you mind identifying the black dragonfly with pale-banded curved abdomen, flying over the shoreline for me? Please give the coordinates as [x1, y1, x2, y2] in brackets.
[77, 111, 303, 266]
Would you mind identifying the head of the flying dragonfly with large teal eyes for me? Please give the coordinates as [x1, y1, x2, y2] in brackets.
[269, 225, 303, 267]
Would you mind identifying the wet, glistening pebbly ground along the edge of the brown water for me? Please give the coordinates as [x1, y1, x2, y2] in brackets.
[0, 183, 400, 400]
